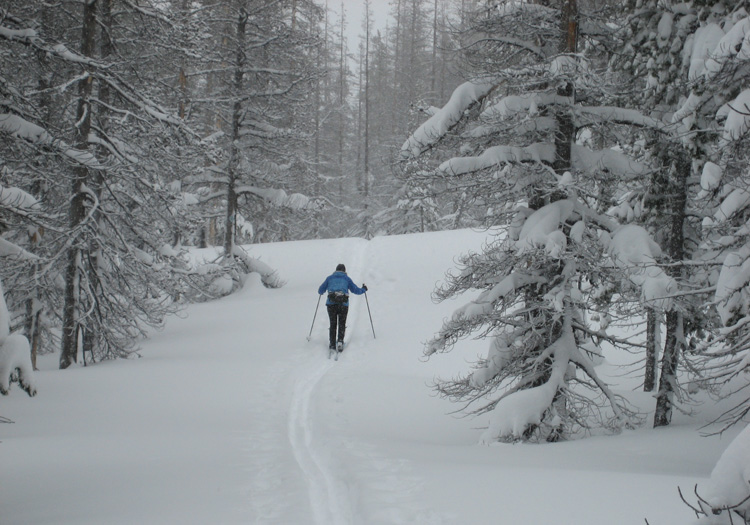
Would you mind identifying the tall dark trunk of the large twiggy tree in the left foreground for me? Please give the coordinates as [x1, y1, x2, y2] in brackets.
[60, 0, 97, 369]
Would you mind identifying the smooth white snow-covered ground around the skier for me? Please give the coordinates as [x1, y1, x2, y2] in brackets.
[0, 231, 740, 525]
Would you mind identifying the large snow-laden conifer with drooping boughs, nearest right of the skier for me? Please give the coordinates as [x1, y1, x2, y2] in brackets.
[402, 0, 677, 442]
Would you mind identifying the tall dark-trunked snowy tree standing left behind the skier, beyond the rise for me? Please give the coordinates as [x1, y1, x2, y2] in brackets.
[183, 0, 319, 257]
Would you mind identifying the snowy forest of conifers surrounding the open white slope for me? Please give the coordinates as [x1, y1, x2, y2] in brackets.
[0, 0, 750, 454]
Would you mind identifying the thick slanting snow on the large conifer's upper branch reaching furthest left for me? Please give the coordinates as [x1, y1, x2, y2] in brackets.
[401, 81, 496, 158]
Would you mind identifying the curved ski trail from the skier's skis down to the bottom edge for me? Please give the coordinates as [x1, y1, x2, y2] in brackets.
[289, 356, 352, 525]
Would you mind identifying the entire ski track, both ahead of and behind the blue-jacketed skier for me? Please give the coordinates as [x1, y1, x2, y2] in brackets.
[288, 243, 369, 525]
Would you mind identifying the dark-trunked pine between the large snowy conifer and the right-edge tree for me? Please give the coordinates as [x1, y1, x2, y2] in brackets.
[614, 0, 746, 426]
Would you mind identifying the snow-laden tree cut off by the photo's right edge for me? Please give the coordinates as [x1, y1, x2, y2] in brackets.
[675, 4, 750, 427]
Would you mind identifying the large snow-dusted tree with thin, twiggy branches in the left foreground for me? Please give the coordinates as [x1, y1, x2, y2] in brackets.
[0, 4, 226, 368]
